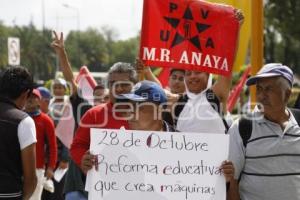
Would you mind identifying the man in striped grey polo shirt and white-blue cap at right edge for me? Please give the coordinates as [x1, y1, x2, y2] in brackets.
[229, 63, 300, 200]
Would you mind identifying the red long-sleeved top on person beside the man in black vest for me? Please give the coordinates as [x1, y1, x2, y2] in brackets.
[32, 112, 57, 169]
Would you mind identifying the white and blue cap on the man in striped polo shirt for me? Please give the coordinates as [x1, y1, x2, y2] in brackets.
[246, 63, 294, 86]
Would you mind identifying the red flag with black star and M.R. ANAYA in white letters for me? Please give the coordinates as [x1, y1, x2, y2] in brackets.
[140, 0, 239, 75]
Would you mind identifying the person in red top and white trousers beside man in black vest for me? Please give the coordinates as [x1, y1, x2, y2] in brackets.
[25, 89, 57, 200]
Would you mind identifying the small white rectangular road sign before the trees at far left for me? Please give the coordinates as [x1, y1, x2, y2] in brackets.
[7, 37, 20, 65]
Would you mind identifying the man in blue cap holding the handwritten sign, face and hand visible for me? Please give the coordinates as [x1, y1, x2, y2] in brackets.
[117, 81, 234, 182]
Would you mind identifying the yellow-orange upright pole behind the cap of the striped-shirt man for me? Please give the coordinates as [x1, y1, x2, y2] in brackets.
[250, 0, 264, 108]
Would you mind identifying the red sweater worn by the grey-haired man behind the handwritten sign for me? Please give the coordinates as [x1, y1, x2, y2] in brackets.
[70, 102, 128, 166]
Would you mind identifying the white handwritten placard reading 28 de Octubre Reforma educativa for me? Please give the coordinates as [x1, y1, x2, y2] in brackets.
[86, 129, 229, 200]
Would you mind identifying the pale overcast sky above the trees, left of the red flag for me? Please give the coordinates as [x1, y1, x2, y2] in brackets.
[0, 0, 143, 39]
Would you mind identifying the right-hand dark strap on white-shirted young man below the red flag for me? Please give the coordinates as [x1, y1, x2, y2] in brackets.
[206, 89, 229, 133]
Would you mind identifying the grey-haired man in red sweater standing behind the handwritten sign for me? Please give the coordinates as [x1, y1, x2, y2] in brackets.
[70, 63, 137, 173]
